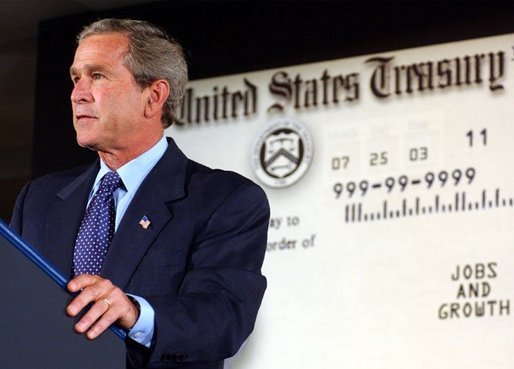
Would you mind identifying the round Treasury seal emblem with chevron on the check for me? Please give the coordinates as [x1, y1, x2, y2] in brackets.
[252, 118, 313, 188]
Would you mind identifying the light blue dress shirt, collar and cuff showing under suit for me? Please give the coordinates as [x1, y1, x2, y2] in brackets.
[88, 136, 168, 347]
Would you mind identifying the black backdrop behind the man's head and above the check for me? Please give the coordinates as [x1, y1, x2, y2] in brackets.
[2, 1, 514, 218]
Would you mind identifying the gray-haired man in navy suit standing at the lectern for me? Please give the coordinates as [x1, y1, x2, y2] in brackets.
[11, 19, 269, 369]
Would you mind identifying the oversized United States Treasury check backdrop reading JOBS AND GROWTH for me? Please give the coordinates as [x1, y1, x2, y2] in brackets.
[167, 35, 514, 369]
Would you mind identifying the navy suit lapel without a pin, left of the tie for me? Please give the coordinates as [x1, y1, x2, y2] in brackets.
[43, 161, 98, 275]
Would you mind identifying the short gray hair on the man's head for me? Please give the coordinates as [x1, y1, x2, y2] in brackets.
[77, 18, 187, 128]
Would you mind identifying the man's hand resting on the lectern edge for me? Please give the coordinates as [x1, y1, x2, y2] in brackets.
[66, 274, 139, 339]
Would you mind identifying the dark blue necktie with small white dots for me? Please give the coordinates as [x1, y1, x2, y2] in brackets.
[73, 172, 121, 275]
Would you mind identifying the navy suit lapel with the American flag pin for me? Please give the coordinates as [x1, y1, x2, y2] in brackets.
[101, 140, 187, 289]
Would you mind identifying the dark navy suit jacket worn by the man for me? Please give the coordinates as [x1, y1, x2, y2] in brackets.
[11, 140, 269, 369]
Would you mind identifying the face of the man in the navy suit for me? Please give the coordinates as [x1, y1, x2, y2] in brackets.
[70, 33, 147, 152]
